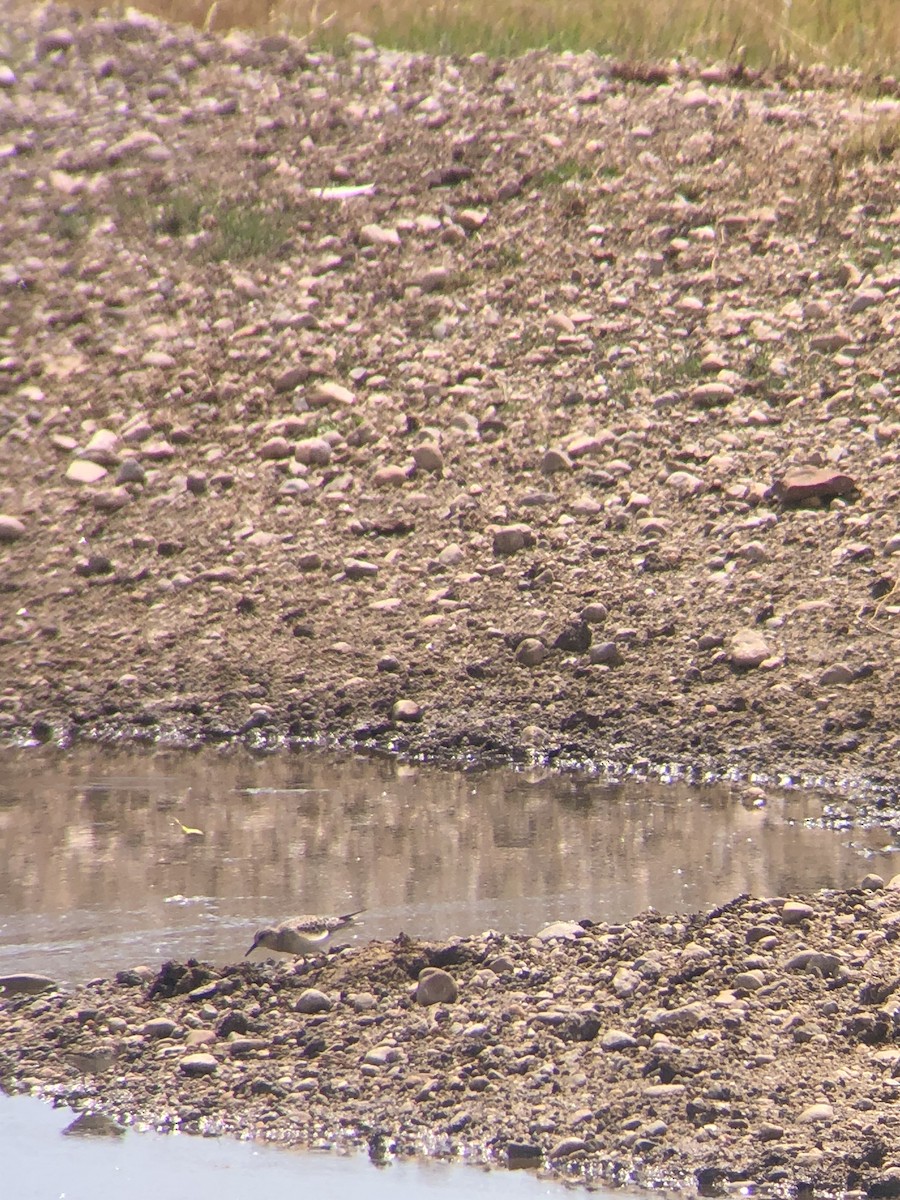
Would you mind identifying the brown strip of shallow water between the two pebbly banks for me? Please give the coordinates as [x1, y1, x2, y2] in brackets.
[0, 751, 894, 978]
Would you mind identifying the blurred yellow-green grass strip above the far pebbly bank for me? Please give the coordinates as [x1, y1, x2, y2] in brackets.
[79, 0, 900, 73]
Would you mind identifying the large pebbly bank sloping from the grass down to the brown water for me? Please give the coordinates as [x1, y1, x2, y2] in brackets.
[0, 7, 900, 781]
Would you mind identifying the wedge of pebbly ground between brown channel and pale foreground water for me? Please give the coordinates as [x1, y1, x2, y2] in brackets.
[7, 876, 900, 1198]
